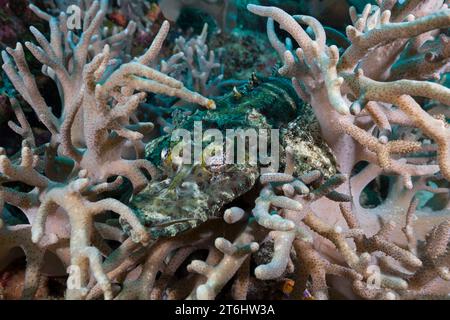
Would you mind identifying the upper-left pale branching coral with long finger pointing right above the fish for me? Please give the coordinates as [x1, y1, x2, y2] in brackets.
[2, 2, 213, 191]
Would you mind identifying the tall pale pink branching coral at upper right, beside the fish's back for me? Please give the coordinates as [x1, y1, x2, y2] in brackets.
[249, 1, 449, 180]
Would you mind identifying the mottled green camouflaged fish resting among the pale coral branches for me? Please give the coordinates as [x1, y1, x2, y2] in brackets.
[123, 75, 336, 238]
